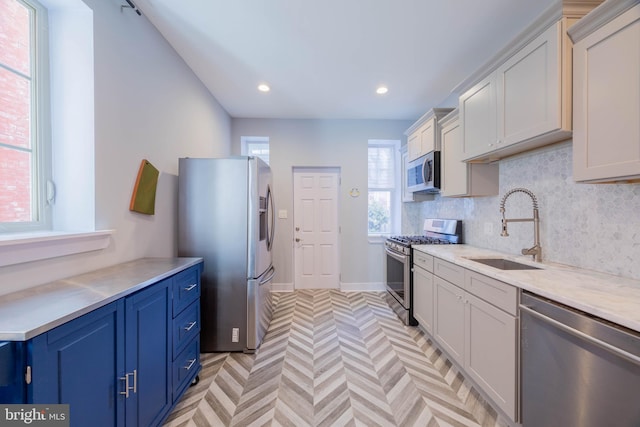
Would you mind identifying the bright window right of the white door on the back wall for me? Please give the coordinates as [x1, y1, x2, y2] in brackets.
[368, 140, 400, 235]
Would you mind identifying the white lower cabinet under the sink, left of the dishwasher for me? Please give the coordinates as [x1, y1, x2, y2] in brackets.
[428, 258, 519, 421]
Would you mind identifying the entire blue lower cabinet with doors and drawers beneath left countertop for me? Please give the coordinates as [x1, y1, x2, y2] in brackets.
[16, 264, 202, 427]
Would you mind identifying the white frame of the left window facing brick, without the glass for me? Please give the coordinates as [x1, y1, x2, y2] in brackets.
[0, 0, 53, 233]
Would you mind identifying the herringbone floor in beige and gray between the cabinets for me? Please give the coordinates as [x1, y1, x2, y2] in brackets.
[165, 290, 506, 427]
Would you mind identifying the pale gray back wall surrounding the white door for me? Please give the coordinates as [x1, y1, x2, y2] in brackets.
[231, 119, 411, 289]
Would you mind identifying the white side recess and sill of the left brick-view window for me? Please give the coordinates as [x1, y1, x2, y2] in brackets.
[0, 0, 114, 267]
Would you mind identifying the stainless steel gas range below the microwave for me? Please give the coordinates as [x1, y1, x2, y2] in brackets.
[384, 219, 462, 325]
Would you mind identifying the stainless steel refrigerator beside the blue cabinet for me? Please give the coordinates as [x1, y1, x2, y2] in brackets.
[178, 156, 275, 353]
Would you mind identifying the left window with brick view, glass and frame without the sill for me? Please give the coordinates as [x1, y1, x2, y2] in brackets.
[0, 0, 51, 232]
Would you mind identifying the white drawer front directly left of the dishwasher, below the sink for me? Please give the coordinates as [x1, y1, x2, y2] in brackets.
[464, 270, 518, 316]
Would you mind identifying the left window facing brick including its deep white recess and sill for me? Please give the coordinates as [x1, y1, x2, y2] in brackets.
[0, 0, 105, 267]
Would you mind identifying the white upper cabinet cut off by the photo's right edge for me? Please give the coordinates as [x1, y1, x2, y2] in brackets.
[570, 0, 640, 182]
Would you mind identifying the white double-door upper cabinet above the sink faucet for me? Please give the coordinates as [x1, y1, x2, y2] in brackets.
[458, 1, 597, 162]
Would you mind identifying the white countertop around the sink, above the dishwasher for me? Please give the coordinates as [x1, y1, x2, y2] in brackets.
[412, 245, 640, 331]
